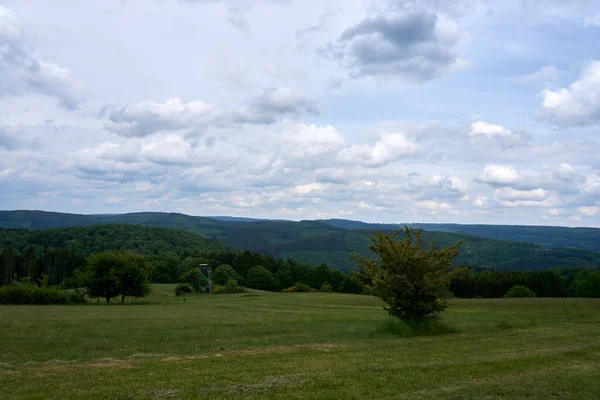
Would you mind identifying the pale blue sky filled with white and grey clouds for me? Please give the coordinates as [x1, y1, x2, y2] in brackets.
[0, 0, 600, 227]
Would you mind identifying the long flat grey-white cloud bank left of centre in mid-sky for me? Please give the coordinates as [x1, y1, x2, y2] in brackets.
[101, 88, 318, 137]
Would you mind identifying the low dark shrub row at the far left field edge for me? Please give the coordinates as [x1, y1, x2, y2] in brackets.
[0, 283, 85, 304]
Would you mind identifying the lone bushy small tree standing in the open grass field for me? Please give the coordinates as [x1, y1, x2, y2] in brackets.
[357, 227, 460, 323]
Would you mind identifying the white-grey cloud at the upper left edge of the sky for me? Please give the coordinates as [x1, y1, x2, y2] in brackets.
[0, 6, 83, 110]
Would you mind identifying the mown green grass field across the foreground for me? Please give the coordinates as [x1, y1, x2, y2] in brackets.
[0, 285, 600, 400]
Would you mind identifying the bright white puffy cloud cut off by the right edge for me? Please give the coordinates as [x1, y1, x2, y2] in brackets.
[541, 61, 600, 128]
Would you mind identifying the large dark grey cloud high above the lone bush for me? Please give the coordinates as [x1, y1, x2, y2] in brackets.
[322, 11, 464, 83]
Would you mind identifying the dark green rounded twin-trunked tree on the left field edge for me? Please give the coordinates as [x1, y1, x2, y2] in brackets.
[80, 251, 150, 303]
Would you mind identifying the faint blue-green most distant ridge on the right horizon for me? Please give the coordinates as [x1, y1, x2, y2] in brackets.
[320, 219, 600, 252]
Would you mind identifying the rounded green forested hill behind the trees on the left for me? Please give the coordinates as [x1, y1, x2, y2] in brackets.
[0, 224, 230, 256]
